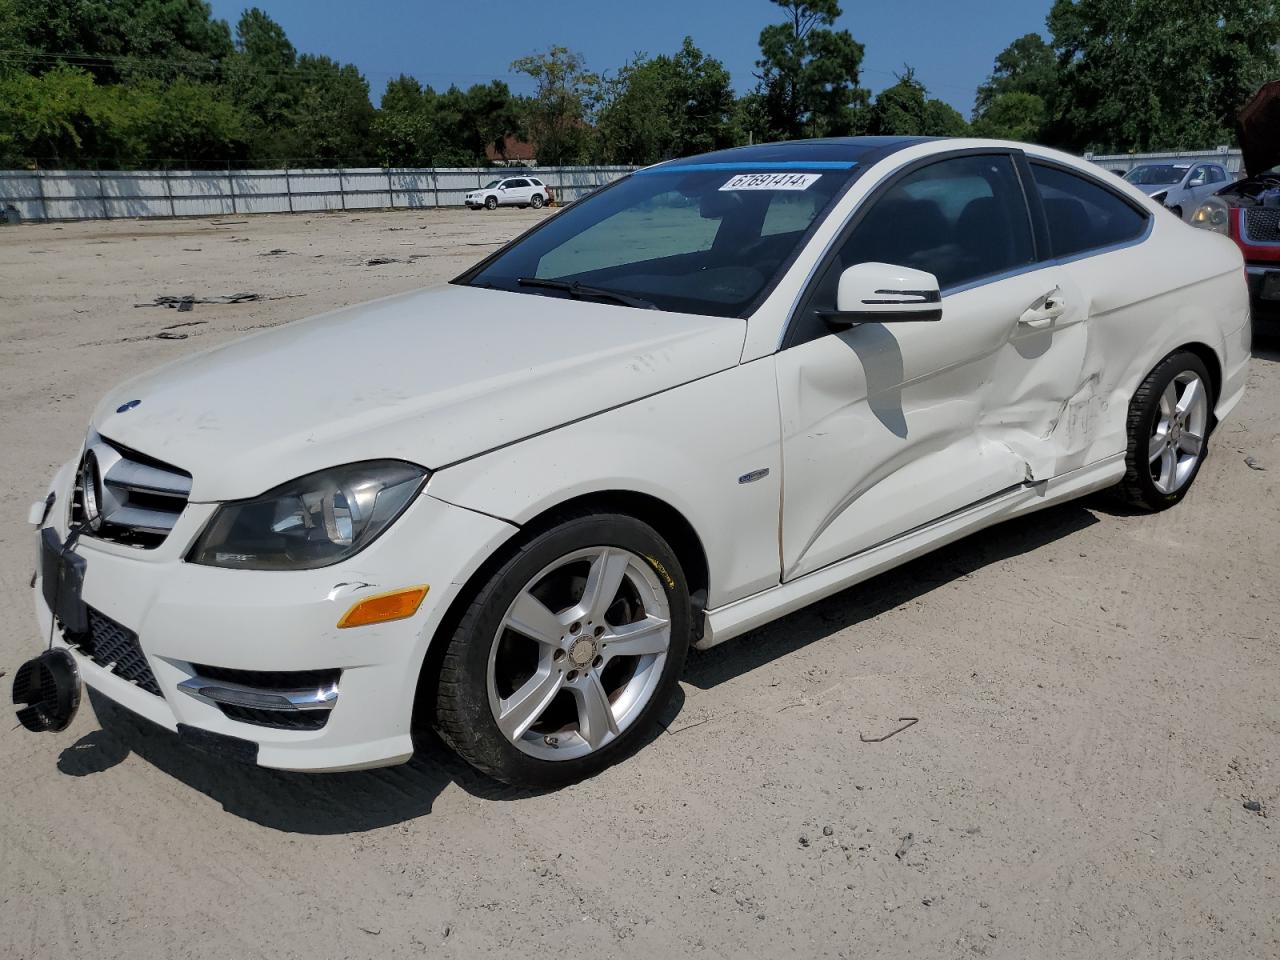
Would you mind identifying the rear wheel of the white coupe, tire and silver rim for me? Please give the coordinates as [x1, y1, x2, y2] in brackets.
[1116, 351, 1213, 511]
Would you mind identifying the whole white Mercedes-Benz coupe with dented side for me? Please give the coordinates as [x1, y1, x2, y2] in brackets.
[32, 138, 1249, 787]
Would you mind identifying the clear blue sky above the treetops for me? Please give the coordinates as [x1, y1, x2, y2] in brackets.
[212, 0, 1051, 116]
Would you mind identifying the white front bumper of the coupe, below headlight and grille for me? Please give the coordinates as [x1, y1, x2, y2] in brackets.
[33, 465, 515, 771]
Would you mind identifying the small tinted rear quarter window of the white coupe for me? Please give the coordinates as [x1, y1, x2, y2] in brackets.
[1032, 163, 1147, 259]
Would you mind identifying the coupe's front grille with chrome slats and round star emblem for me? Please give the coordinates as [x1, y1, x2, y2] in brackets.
[72, 435, 191, 549]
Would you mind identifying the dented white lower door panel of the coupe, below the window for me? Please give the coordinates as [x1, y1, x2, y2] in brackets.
[778, 266, 1089, 579]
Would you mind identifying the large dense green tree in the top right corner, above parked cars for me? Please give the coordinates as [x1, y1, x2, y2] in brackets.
[1048, 0, 1280, 152]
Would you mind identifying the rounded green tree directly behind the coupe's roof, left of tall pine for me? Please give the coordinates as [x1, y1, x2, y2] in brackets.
[598, 37, 739, 164]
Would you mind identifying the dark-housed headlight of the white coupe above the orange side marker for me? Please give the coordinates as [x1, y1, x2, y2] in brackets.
[189, 460, 428, 570]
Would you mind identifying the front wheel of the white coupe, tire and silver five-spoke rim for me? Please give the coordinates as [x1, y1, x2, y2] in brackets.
[435, 513, 692, 788]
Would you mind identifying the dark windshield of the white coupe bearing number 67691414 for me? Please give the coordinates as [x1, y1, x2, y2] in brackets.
[458, 163, 854, 316]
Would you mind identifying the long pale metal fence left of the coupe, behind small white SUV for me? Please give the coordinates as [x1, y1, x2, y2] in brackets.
[0, 166, 635, 220]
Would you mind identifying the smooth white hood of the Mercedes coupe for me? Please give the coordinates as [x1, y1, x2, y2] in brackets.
[93, 285, 746, 502]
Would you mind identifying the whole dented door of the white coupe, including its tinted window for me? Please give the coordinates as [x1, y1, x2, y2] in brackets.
[776, 151, 1087, 580]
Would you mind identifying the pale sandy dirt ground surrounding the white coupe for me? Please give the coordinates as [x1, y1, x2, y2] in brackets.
[0, 210, 1280, 960]
